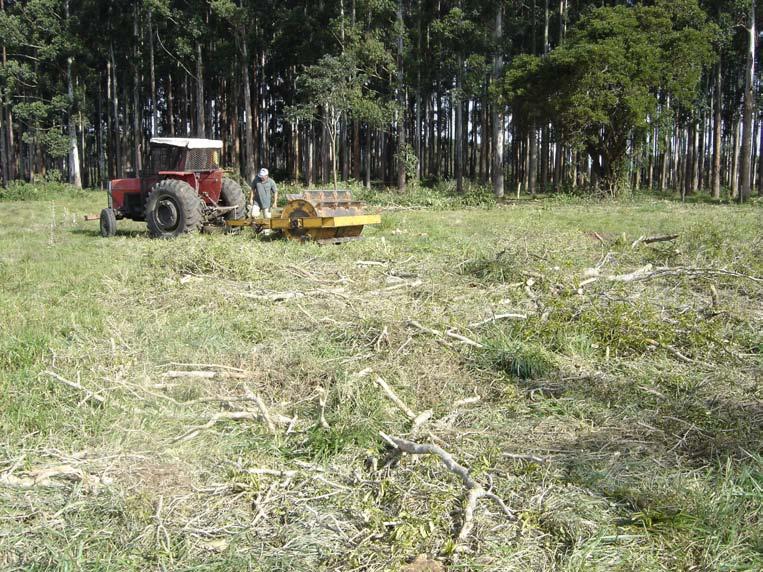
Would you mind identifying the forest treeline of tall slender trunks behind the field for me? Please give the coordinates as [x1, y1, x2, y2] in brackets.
[0, 0, 763, 200]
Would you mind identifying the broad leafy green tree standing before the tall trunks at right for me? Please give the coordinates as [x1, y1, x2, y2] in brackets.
[498, 0, 717, 191]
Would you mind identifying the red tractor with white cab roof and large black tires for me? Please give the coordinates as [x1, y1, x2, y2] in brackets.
[101, 137, 246, 238]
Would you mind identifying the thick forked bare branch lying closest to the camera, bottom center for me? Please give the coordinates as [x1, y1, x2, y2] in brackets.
[379, 431, 516, 551]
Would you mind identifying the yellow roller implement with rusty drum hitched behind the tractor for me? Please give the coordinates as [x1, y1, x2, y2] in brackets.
[226, 191, 381, 243]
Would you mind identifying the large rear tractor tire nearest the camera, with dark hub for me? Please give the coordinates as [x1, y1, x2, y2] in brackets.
[146, 179, 202, 238]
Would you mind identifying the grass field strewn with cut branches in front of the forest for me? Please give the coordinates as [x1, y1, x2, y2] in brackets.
[0, 185, 763, 571]
